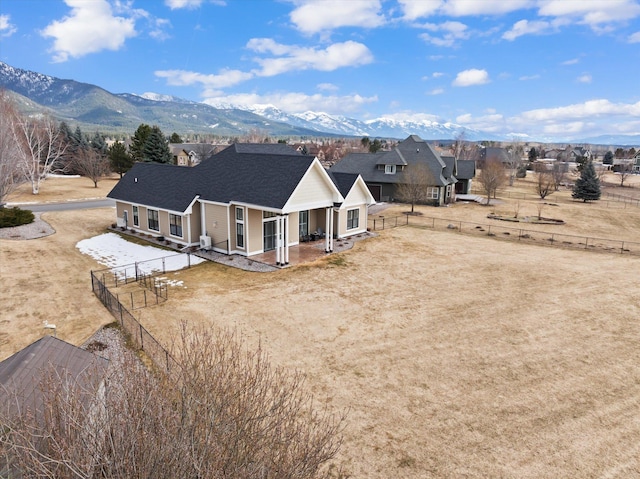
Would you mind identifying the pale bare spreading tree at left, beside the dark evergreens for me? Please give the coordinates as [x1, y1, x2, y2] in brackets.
[15, 117, 66, 195]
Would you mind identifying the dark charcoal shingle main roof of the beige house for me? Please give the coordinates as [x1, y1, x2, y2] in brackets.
[107, 143, 314, 212]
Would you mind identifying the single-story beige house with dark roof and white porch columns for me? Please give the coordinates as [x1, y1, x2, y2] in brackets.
[107, 143, 375, 264]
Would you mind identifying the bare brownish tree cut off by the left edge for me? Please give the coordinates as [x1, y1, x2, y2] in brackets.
[0, 91, 24, 205]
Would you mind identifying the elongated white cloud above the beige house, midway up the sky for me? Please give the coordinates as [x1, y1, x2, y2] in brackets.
[247, 38, 373, 76]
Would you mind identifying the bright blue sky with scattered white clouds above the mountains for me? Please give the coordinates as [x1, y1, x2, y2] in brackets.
[0, 0, 640, 139]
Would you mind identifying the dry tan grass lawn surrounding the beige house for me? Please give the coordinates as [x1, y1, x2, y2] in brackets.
[0, 174, 640, 478]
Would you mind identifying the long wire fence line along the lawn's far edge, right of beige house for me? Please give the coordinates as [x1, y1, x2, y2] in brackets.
[368, 215, 640, 256]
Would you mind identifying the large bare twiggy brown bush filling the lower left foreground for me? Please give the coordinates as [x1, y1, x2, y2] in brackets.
[0, 323, 345, 479]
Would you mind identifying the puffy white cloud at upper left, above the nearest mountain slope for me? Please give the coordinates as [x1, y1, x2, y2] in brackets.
[41, 0, 137, 62]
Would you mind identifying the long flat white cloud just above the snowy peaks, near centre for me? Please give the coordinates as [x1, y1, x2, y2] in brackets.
[204, 92, 378, 115]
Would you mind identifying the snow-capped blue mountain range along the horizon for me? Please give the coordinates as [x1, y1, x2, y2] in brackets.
[0, 62, 640, 145]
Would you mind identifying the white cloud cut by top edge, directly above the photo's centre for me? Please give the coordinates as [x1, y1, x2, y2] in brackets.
[289, 0, 386, 34]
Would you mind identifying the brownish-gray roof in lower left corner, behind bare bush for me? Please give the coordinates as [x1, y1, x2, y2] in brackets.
[0, 336, 108, 418]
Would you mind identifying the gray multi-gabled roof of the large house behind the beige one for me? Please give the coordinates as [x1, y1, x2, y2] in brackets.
[331, 135, 455, 186]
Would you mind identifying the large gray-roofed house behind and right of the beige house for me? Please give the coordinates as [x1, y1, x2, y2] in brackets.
[329, 135, 464, 205]
